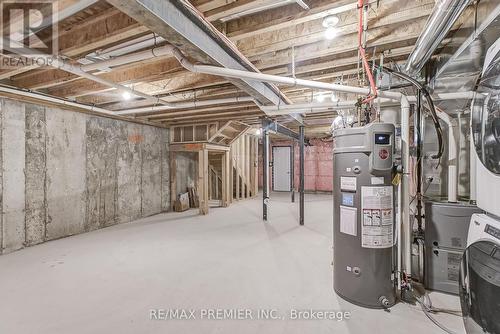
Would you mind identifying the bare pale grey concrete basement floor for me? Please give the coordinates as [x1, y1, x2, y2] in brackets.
[0, 194, 464, 334]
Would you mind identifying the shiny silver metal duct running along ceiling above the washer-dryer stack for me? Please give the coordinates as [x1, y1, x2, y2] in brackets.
[405, 0, 472, 76]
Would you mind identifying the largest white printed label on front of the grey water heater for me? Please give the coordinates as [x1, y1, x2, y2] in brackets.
[361, 186, 394, 248]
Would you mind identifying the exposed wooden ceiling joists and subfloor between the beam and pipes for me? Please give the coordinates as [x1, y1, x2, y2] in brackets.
[0, 0, 442, 132]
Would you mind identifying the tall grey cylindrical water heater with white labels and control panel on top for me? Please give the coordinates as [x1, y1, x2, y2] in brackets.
[333, 123, 396, 308]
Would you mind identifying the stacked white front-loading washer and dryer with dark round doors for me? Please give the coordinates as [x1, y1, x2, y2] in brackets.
[459, 39, 500, 334]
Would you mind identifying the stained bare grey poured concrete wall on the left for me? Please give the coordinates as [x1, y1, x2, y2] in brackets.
[0, 99, 170, 253]
